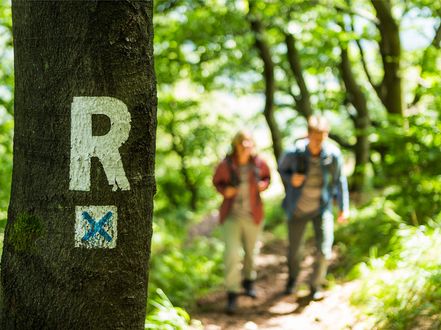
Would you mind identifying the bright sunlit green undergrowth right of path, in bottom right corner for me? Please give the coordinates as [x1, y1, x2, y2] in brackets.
[353, 224, 441, 330]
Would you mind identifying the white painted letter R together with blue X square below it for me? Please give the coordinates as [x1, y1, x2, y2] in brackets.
[69, 96, 131, 249]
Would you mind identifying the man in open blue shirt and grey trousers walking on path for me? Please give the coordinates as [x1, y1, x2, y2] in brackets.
[279, 116, 349, 300]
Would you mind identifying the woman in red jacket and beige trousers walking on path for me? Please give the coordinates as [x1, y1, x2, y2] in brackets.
[213, 131, 270, 314]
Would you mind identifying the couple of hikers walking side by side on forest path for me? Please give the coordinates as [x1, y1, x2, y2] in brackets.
[213, 116, 349, 314]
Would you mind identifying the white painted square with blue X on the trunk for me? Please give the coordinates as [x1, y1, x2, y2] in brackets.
[75, 205, 118, 249]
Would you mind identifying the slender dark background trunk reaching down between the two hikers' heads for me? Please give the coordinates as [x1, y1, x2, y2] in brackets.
[248, 7, 282, 160]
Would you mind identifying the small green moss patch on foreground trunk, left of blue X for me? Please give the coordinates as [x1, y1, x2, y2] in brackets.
[9, 213, 44, 252]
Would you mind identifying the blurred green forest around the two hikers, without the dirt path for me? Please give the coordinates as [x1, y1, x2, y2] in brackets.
[0, 0, 441, 329]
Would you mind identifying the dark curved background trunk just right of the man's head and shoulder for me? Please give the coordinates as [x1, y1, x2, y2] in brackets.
[340, 46, 370, 192]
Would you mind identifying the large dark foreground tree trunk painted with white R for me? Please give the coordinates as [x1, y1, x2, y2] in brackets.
[0, 0, 156, 329]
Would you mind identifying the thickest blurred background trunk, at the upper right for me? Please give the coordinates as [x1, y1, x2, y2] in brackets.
[371, 0, 404, 115]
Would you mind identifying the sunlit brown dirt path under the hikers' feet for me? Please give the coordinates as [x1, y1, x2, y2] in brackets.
[190, 218, 366, 330]
